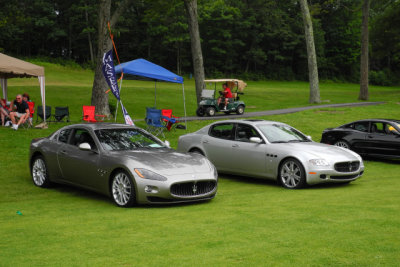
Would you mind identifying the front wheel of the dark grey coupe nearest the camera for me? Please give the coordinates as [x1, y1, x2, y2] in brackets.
[110, 171, 136, 208]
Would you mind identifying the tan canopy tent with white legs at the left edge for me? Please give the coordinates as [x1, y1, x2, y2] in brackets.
[0, 53, 46, 121]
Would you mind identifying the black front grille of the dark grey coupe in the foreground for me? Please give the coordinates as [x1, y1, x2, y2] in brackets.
[171, 181, 217, 197]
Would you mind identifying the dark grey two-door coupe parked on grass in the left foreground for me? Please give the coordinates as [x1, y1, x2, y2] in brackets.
[29, 123, 218, 207]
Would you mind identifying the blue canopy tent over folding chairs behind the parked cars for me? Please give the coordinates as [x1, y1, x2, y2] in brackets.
[115, 58, 186, 126]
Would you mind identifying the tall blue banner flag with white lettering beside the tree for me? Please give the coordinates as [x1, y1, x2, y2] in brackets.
[101, 49, 135, 125]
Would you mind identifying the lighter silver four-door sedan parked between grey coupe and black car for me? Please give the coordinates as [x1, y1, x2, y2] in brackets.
[178, 120, 364, 188]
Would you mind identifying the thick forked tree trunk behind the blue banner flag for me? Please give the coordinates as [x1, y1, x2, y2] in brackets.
[91, 0, 129, 117]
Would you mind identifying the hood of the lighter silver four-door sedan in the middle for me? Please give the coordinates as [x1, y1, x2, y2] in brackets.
[285, 142, 361, 162]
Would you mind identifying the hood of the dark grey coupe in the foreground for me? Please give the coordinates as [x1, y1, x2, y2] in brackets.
[108, 148, 212, 175]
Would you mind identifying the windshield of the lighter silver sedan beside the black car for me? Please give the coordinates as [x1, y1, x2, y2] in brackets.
[258, 124, 311, 143]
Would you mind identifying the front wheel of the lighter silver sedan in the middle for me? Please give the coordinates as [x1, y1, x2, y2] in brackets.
[278, 158, 306, 189]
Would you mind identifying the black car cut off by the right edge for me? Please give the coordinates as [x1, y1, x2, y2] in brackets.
[321, 119, 400, 158]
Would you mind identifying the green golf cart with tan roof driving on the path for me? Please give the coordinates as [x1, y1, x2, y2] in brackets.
[196, 79, 247, 117]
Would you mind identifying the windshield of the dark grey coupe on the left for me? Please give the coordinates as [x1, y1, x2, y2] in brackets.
[95, 129, 165, 151]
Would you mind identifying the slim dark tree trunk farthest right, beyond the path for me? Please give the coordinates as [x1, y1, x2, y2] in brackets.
[358, 0, 370, 100]
